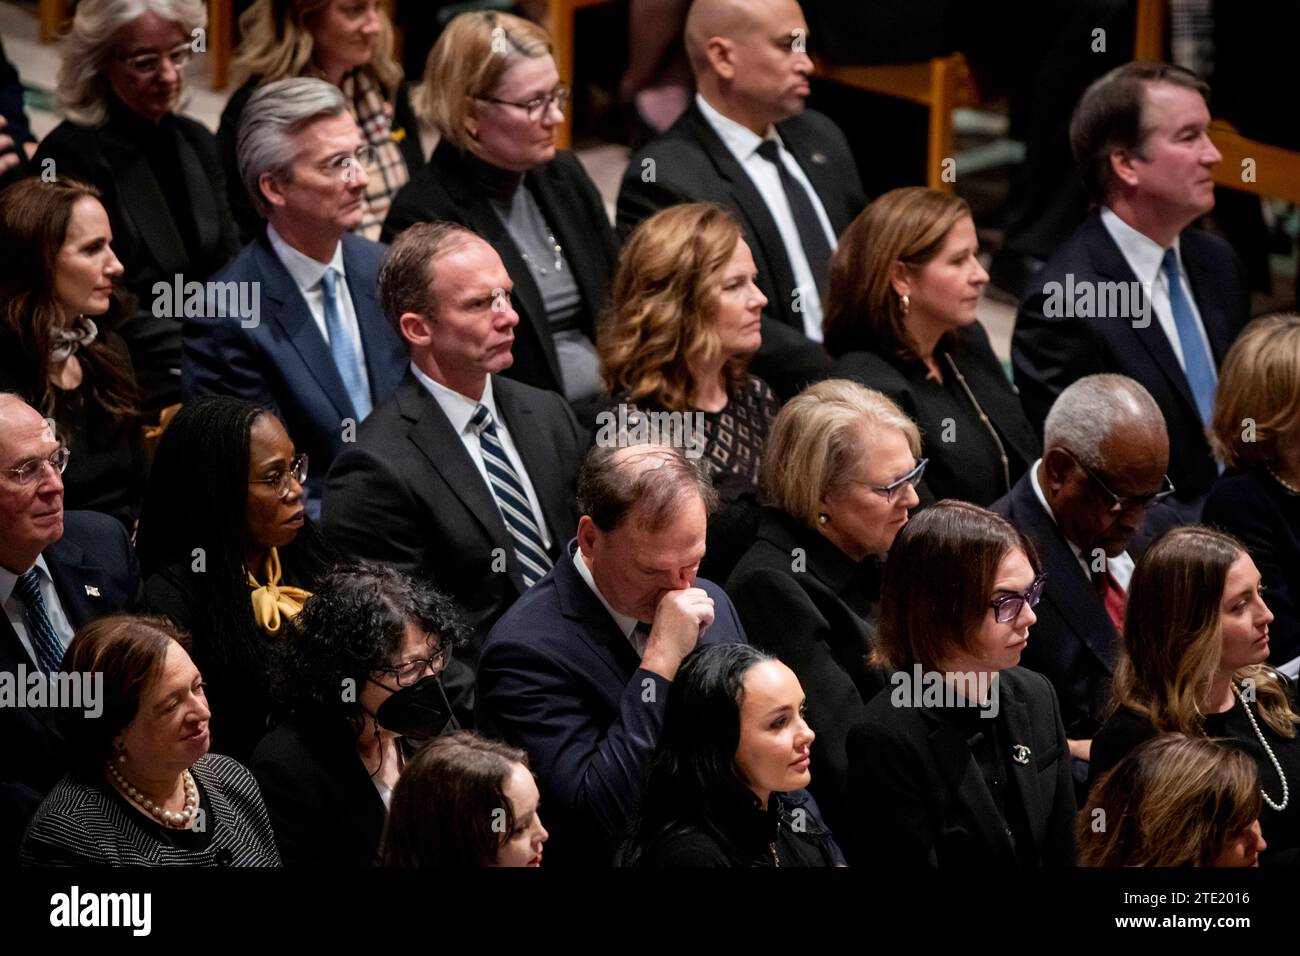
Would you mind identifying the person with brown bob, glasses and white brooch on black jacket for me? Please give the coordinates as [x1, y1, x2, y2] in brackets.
[846, 501, 1075, 870]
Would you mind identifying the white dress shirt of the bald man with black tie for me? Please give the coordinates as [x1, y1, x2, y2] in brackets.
[696, 94, 836, 342]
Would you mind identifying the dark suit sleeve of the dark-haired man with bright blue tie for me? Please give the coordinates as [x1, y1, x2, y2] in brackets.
[1011, 289, 1108, 436]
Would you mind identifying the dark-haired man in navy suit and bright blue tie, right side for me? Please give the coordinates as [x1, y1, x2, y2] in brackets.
[1011, 62, 1251, 519]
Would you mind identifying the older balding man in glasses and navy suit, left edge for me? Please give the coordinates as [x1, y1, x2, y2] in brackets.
[0, 393, 143, 862]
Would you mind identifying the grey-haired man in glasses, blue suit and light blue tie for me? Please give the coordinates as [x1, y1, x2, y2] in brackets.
[183, 78, 406, 518]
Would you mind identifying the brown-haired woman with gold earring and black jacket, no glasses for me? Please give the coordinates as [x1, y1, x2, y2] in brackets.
[826, 186, 1043, 506]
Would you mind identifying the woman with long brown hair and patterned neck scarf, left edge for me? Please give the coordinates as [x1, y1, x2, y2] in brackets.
[0, 177, 148, 532]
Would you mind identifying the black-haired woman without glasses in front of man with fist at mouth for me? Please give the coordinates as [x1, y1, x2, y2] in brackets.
[618, 644, 842, 866]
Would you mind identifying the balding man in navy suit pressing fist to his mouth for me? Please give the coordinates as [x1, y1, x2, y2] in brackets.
[478, 442, 745, 866]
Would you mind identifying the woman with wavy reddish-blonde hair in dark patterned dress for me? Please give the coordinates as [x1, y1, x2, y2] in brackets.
[599, 203, 780, 580]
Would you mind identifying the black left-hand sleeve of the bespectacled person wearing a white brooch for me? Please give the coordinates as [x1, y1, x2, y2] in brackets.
[846, 717, 939, 869]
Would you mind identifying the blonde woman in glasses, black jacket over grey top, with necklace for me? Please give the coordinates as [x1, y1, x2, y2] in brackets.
[384, 12, 619, 424]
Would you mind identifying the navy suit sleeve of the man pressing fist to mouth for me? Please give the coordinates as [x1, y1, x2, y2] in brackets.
[478, 642, 668, 840]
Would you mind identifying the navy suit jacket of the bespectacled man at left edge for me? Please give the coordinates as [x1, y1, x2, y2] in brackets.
[0, 511, 144, 858]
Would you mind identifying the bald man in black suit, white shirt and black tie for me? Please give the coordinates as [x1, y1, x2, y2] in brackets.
[618, 0, 866, 397]
